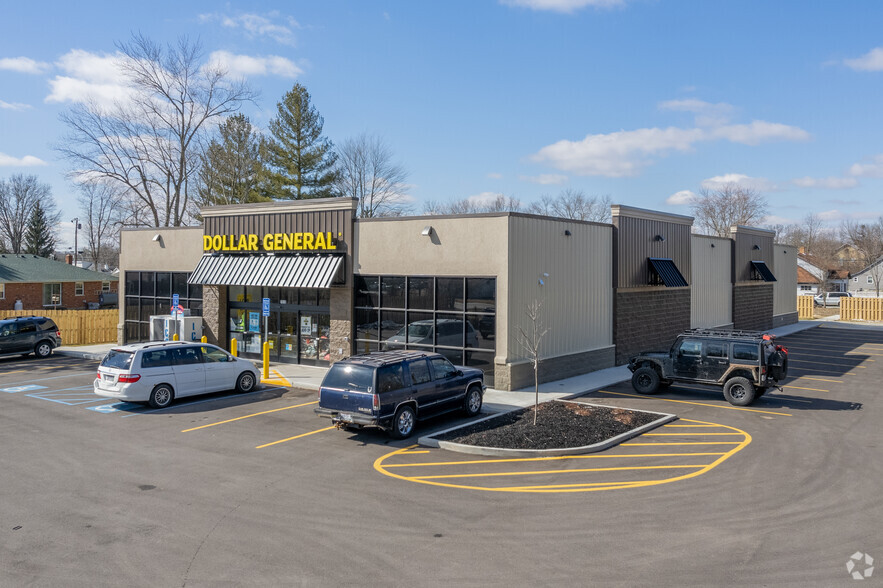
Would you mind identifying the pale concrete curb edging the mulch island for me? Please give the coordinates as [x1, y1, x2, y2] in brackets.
[417, 398, 678, 457]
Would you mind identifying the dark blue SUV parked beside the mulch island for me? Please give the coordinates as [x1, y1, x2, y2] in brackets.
[314, 351, 485, 439]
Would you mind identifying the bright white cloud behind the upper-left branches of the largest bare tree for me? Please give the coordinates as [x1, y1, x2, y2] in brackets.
[46, 49, 133, 107]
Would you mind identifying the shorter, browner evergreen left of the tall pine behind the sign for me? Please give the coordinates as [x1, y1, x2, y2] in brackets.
[197, 114, 270, 206]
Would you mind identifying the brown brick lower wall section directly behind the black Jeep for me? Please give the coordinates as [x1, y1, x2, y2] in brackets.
[613, 288, 692, 365]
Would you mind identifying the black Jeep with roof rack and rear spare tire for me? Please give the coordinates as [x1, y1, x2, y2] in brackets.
[628, 329, 788, 406]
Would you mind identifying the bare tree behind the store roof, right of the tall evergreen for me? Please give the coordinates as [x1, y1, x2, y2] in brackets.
[334, 133, 408, 218]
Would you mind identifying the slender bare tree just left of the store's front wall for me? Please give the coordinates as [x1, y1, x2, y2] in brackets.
[77, 183, 124, 269]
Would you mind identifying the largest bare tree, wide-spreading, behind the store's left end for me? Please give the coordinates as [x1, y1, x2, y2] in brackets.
[56, 35, 255, 227]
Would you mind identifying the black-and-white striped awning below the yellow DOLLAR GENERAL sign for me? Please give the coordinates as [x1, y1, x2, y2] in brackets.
[187, 254, 343, 288]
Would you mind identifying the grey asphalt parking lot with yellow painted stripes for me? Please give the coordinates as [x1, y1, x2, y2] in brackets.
[0, 325, 883, 586]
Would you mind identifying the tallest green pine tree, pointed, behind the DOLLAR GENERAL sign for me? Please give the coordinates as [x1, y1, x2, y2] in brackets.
[268, 84, 337, 200]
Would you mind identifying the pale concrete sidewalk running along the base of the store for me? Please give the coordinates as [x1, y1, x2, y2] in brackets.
[54, 321, 820, 412]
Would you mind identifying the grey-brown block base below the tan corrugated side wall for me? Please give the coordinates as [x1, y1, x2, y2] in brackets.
[498, 347, 614, 390]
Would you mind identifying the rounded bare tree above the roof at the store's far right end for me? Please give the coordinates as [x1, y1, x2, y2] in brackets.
[690, 184, 767, 237]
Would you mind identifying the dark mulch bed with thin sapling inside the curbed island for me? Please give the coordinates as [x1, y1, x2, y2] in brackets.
[435, 401, 660, 449]
